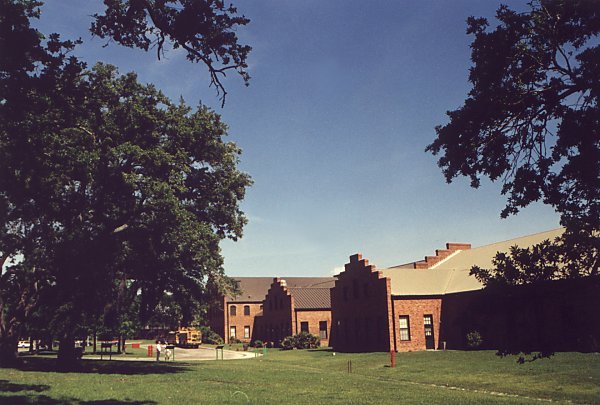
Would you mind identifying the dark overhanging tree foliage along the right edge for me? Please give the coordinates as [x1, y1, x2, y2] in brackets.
[427, 0, 600, 279]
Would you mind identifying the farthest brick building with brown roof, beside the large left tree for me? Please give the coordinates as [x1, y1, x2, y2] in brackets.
[208, 277, 334, 343]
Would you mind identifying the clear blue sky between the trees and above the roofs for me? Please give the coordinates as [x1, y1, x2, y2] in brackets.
[36, 0, 559, 276]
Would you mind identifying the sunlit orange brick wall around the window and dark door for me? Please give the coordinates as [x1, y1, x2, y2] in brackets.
[392, 297, 442, 352]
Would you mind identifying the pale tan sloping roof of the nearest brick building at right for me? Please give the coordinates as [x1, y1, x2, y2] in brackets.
[380, 228, 564, 295]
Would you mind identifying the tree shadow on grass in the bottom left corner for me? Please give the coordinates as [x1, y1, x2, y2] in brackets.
[0, 380, 156, 405]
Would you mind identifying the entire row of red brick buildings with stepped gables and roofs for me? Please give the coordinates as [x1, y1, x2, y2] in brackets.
[209, 229, 600, 352]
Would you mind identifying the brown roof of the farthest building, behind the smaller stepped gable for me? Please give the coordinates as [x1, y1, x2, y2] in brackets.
[229, 277, 335, 302]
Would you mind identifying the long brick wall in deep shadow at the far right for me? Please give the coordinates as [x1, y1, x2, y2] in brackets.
[441, 277, 600, 352]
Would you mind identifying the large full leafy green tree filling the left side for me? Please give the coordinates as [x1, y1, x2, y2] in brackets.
[0, 0, 251, 358]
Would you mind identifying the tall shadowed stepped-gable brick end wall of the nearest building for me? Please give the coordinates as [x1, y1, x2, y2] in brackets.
[330, 254, 394, 352]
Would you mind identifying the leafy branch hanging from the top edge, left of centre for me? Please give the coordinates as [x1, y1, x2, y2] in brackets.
[91, 0, 252, 104]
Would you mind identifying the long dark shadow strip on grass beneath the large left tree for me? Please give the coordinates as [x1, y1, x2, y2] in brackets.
[10, 358, 189, 375]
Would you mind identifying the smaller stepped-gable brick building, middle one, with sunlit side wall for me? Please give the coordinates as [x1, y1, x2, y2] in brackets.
[256, 278, 333, 346]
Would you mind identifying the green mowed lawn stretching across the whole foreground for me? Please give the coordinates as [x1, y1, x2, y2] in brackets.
[0, 350, 600, 404]
